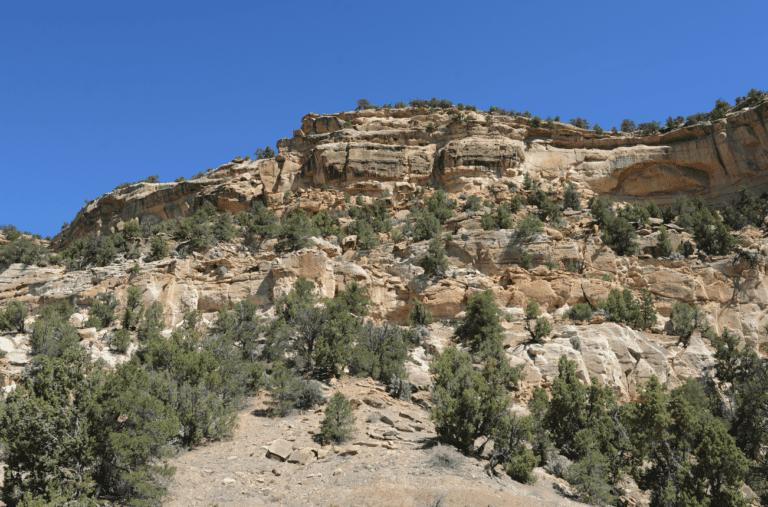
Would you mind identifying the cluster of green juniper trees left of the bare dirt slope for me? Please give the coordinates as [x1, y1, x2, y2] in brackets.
[0, 278, 432, 506]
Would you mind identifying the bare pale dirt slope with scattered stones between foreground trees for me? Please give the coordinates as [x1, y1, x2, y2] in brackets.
[164, 378, 581, 507]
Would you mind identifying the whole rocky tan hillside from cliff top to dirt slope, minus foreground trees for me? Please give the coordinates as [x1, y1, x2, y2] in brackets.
[0, 96, 768, 505]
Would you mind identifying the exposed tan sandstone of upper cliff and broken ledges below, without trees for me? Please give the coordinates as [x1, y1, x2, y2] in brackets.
[0, 102, 768, 503]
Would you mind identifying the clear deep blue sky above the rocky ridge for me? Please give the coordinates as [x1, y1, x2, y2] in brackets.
[0, 0, 768, 236]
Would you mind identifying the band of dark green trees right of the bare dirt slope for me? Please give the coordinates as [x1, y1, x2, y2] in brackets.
[430, 291, 768, 507]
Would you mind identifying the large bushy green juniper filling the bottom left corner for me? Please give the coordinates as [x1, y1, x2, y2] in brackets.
[0, 349, 178, 505]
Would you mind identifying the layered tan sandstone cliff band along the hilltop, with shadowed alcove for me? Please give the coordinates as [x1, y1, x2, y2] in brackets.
[54, 101, 768, 244]
